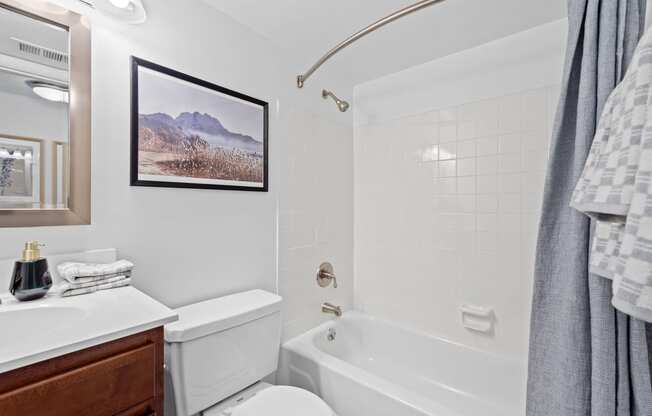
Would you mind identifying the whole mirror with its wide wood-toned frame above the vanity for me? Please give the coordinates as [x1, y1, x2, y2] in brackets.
[0, 0, 91, 227]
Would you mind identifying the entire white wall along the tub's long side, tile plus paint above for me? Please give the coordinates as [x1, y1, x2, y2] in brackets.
[354, 21, 566, 359]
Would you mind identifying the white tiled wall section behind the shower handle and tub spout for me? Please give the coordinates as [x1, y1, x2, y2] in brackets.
[279, 110, 353, 339]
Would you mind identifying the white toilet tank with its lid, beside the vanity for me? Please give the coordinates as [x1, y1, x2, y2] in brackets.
[165, 290, 281, 416]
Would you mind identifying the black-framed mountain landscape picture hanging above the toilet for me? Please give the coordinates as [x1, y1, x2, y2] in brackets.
[131, 57, 269, 192]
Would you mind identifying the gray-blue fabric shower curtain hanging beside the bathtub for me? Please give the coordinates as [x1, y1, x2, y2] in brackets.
[527, 0, 652, 416]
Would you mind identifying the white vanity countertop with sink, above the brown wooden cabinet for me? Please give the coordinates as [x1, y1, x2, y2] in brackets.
[0, 286, 178, 373]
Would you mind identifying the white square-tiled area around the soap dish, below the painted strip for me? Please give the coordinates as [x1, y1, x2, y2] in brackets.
[356, 87, 557, 353]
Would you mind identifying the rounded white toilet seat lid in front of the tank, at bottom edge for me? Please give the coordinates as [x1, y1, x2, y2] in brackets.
[231, 386, 336, 416]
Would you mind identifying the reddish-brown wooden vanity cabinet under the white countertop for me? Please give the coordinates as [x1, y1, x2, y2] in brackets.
[0, 327, 164, 416]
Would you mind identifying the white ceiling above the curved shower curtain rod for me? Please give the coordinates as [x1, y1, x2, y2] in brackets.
[202, 0, 566, 85]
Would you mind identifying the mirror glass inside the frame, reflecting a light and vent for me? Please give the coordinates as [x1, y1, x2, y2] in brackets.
[0, 7, 70, 209]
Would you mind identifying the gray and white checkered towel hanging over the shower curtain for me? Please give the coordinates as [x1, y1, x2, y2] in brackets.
[570, 31, 652, 322]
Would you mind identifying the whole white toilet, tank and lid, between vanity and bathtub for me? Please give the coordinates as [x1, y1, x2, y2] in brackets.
[165, 290, 335, 416]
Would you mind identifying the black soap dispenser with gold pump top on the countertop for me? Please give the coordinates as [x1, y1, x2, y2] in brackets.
[9, 241, 52, 301]
